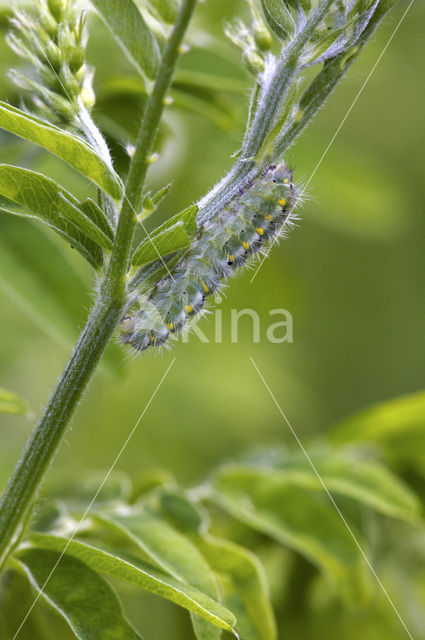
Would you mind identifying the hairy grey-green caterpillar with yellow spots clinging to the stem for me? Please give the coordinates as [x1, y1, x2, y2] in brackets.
[120, 164, 297, 351]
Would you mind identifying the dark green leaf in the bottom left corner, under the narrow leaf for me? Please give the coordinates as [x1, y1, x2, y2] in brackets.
[17, 549, 141, 640]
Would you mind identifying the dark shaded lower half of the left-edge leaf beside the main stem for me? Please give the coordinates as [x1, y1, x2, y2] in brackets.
[0, 195, 103, 269]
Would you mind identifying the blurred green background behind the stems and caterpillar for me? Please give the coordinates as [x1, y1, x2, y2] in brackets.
[0, 0, 425, 640]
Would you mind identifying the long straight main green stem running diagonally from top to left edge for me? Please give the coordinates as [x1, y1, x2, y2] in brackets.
[0, 0, 197, 567]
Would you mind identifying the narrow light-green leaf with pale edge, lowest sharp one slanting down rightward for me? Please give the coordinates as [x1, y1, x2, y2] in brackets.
[25, 534, 236, 632]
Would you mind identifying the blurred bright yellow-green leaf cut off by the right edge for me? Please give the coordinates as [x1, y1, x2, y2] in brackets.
[330, 391, 425, 474]
